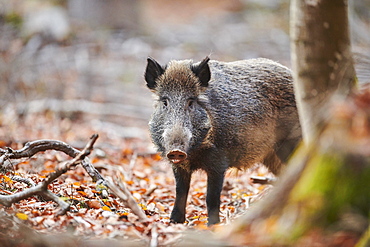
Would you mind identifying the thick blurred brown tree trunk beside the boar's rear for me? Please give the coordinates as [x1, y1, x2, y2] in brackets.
[290, 0, 355, 143]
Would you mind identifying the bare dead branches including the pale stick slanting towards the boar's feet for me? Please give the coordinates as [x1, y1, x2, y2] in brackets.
[0, 134, 147, 221]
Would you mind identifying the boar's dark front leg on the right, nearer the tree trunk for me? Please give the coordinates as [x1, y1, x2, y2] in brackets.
[206, 168, 226, 225]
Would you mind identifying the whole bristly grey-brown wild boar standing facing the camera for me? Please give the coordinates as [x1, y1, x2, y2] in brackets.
[145, 57, 301, 224]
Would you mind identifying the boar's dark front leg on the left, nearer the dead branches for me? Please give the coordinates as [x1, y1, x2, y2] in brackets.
[170, 167, 191, 223]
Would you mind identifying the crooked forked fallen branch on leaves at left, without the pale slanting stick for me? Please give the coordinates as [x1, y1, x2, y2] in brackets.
[0, 134, 99, 215]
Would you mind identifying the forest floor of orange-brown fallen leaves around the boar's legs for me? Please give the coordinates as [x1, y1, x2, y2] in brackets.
[0, 112, 273, 246]
